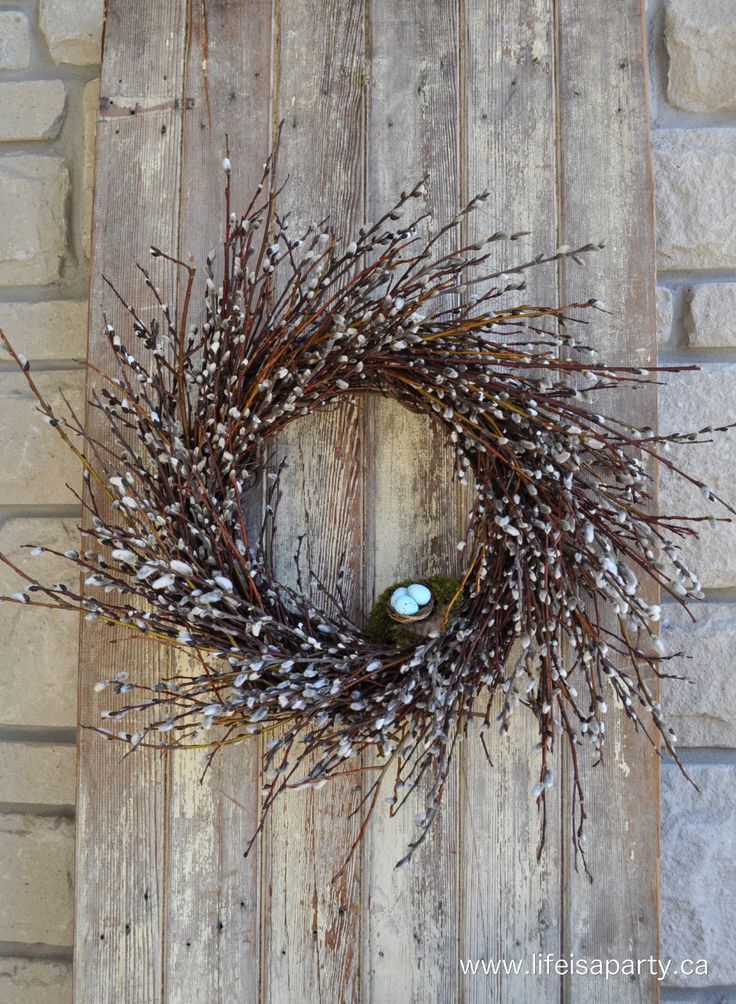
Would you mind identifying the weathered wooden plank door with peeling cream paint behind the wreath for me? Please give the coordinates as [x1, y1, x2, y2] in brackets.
[75, 0, 658, 1004]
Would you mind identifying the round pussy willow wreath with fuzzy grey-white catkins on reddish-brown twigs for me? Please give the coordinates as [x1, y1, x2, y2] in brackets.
[3, 146, 733, 863]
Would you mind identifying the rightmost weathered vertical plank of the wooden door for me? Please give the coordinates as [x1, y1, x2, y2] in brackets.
[558, 0, 659, 1002]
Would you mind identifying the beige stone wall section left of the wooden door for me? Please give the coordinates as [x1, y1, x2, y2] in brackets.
[0, 0, 102, 1004]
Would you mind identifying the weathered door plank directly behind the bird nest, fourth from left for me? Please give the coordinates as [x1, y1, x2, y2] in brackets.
[361, 0, 462, 1004]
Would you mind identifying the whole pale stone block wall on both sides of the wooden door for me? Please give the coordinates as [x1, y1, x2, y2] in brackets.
[0, 0, 736, 1004]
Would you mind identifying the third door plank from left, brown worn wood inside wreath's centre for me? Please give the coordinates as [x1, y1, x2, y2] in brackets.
[262, 0, 364, 1004]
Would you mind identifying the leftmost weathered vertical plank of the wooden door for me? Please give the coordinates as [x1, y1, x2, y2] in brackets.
[74, 0, 187, 1004]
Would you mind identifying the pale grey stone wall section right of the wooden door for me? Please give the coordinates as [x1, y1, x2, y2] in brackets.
[649, 0, 736, 1004]
